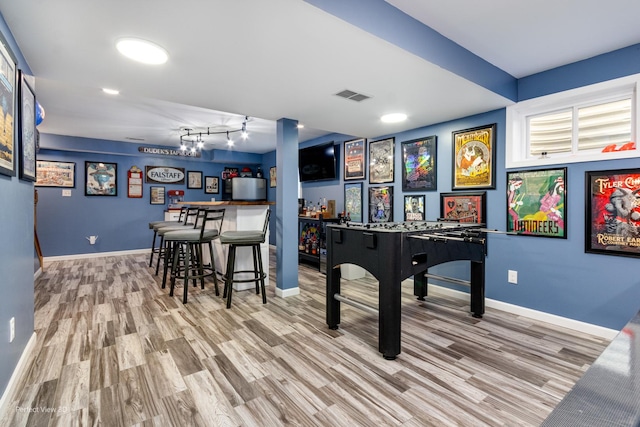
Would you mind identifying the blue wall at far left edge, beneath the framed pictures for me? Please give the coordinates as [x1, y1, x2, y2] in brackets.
[0, 12, 34, 402]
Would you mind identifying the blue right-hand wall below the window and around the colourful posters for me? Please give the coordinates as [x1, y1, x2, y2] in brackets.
[302, 104, 640, 329]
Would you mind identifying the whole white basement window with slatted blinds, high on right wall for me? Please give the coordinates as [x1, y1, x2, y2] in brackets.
[506, 75, 640, 168]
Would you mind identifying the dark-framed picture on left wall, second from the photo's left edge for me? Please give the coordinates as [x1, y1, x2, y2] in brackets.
[18, 71, 36, 181]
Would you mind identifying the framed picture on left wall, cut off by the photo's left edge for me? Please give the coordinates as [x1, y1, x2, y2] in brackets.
[0, 33, 17, 176]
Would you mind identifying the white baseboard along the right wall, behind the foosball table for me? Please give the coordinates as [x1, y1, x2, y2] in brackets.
[424, 282, 620, 340]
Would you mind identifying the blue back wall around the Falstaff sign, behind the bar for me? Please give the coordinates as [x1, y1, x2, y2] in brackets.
[37, 135, 262, 257]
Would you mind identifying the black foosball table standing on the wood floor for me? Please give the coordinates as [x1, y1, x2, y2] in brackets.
[327, 221, 488, 360]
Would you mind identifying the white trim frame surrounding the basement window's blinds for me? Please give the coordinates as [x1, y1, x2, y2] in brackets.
[505, 74, 640, 169]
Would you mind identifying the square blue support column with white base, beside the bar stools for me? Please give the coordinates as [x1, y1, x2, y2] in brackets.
[276, 118, 300, 298]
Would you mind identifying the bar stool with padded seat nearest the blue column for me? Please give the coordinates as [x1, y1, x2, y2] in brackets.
[220, 209, 271, 308]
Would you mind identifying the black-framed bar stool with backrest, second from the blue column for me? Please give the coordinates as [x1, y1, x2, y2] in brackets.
[163, 209, 225, 304]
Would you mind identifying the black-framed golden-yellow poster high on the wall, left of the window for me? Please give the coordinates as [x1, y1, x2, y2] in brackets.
[452, 123, 496, 190]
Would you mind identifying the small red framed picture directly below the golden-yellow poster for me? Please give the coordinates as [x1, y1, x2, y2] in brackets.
[440, 191, 487, 224]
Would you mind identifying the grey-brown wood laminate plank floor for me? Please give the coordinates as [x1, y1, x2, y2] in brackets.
[0, 251, 607, 427]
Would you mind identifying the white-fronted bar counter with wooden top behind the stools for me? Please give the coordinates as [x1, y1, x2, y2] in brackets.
[179, 200, 275, 291]
